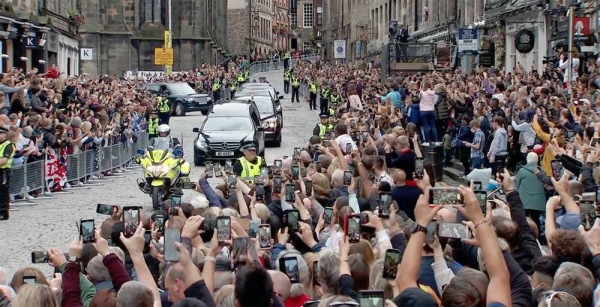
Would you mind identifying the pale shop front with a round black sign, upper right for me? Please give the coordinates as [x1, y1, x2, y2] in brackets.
[504, 10, 548, 72]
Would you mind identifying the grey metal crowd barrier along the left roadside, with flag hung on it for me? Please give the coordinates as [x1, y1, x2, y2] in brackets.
[9, 132, 149, 202]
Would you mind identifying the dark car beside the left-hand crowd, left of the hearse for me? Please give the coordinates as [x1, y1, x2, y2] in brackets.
[145, 82, 213, 116]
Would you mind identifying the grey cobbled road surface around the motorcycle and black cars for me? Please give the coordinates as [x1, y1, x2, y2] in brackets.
[0, 70, 318, 278]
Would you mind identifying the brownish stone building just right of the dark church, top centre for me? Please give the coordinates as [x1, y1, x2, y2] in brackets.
[229, 0, 281, 54]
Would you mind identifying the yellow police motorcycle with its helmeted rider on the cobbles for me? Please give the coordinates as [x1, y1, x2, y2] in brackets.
[135, 125, 193, 210]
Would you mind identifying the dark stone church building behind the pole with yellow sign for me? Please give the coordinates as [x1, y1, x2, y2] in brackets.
[79, 0, 228, 75]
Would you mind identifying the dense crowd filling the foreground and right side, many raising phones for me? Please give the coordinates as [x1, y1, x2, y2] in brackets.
[0, 45, 600, 307]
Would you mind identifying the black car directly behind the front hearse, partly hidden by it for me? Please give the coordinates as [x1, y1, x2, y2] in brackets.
[232, 96, 283, 147]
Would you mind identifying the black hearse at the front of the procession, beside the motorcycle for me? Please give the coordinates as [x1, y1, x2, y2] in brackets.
[193, 101, 265, 166]
